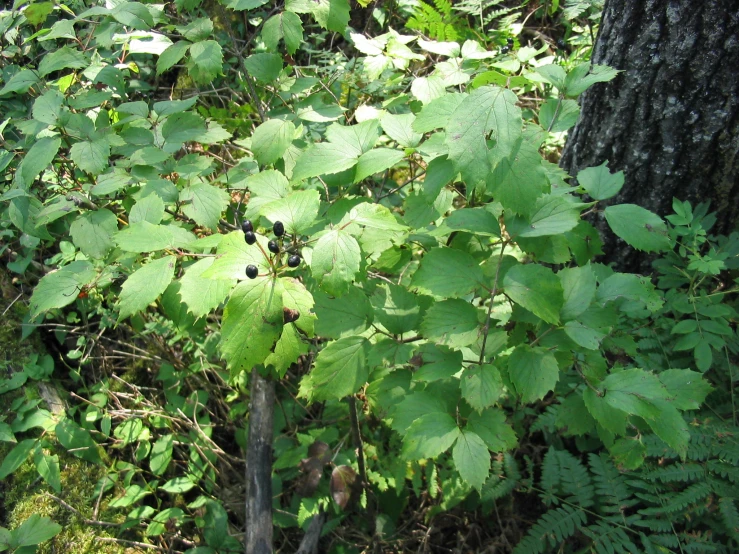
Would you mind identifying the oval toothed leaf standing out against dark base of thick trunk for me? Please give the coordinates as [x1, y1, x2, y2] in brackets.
[605, 204, 672, 252]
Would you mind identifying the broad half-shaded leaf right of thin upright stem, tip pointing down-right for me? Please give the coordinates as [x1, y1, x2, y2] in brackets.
[503, 264, 564, 324]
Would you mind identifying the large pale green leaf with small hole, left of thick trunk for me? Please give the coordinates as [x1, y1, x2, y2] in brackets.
[446, 86, 520, 187]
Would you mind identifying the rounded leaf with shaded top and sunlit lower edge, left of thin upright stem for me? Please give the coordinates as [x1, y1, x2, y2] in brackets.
[420, 299, 480, 347]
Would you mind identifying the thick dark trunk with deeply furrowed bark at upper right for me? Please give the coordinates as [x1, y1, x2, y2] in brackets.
[560, 0, 739, 272]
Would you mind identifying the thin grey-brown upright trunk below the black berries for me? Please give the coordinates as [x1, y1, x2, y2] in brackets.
[245, 369, 275, 554]
